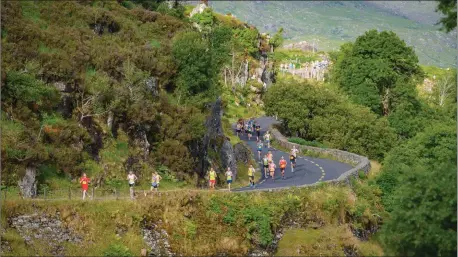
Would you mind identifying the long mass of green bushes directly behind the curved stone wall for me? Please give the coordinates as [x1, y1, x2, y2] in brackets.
[264, 77, 396, 160]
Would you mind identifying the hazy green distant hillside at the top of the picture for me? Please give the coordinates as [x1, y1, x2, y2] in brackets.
[209, 1, 456, 67]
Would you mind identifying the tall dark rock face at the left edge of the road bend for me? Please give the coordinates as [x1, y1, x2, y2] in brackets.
[201, 97, 237, 179]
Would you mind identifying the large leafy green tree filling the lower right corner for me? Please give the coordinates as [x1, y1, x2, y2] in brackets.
[377, 123, 457, 256]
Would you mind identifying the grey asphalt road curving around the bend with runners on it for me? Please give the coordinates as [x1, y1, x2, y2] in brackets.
[233, 117, 353, 191]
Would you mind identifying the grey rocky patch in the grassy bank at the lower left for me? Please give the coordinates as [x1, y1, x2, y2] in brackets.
[10, 213, 82, 255]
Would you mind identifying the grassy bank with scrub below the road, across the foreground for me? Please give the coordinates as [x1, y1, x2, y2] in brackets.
[1, 176, 383, 256]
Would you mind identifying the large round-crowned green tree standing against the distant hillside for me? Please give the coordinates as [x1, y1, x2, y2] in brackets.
[332, 30, 422, 116]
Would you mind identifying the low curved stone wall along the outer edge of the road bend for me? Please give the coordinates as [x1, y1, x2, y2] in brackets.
[270, 126, 371, 187]
